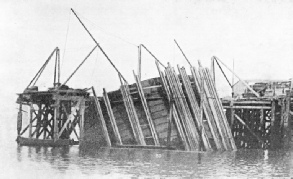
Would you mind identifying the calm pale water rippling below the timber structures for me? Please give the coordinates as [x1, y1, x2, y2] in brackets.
[0, 118, 293, 178]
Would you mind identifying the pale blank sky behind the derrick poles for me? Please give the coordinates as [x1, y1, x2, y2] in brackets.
[0, 0, 293, 117]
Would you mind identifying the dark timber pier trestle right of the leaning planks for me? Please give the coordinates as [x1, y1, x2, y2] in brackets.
[223, 91, 292, 149]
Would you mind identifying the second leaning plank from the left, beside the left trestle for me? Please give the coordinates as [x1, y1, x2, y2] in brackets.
[103, 88, 122, 145]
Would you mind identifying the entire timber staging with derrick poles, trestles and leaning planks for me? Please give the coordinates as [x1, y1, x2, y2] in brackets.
[16, 10, 293, 151]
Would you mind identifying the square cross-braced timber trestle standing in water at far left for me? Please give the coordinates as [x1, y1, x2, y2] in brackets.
[17, 89, 89, 146]
